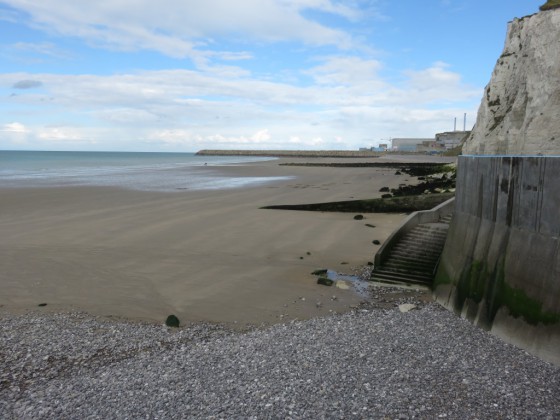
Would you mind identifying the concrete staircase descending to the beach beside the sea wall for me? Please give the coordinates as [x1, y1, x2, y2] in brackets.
[371, 214, 452, 286]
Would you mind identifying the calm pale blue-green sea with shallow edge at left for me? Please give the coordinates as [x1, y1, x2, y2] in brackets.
[0, 151, 288, 191]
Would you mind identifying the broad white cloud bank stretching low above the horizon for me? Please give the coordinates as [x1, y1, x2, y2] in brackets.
[0, 56, 482, 150]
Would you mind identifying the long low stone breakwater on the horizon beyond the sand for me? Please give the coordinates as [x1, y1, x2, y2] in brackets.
[196, 149, 380, 158]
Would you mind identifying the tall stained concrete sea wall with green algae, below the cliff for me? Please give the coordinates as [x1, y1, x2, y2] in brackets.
[434, 156, 560, 365]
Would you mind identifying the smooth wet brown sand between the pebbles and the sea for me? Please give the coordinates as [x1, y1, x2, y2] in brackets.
[0, 159, 448, 326]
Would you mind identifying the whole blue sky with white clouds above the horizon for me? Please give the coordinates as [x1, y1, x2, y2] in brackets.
[0, 0, 545, 152]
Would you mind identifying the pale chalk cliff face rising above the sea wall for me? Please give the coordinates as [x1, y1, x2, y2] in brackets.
[463, 9, 560, 155]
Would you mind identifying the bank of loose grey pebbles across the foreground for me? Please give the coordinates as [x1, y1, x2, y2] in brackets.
[0, 303, 560, 419]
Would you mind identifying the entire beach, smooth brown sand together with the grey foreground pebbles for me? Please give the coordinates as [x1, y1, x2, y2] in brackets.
[0, 155, 560, 419]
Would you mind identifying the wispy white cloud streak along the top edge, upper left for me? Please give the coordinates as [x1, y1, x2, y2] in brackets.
[5, 0, 359, 58]
